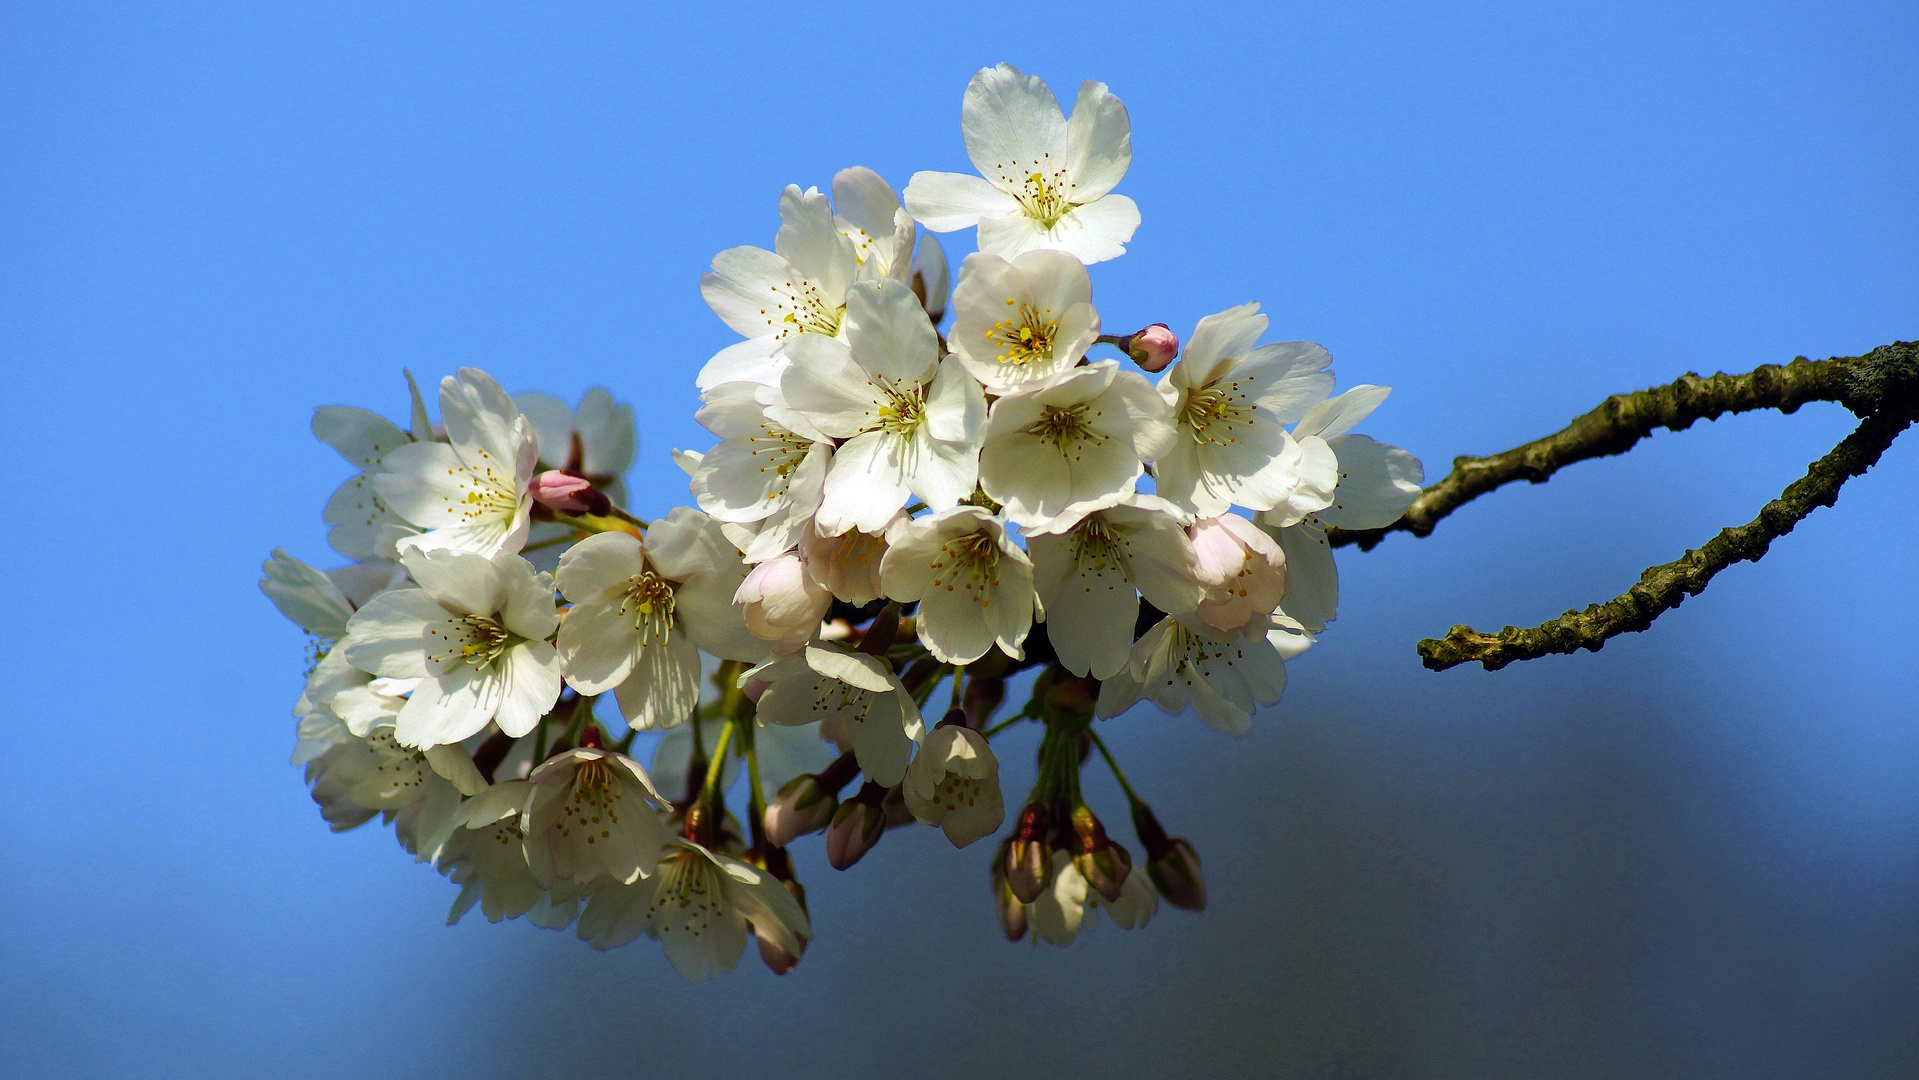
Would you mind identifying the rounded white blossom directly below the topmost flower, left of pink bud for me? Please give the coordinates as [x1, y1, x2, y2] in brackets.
[946, 251, 1100, 393]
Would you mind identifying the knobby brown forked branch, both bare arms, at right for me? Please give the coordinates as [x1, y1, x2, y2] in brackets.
[1328, 341, 1919, 671]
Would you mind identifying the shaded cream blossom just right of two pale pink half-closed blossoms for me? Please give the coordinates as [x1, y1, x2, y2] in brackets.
[879, 506, 1044, 664]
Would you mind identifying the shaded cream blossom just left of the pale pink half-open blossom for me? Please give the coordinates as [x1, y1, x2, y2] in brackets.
[1027, 495, 1203, 679]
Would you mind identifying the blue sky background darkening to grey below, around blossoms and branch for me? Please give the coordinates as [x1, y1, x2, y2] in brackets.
[0, 0, 1919, 1078]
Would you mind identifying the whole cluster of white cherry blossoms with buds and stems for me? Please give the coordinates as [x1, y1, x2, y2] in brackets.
[261, 63, 1422, 980]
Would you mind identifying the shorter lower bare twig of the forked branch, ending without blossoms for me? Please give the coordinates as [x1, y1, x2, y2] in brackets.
[1409, 341, 1919, 671]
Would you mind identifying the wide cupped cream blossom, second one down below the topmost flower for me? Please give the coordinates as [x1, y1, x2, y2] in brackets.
[979, 361, 1174, 526]
